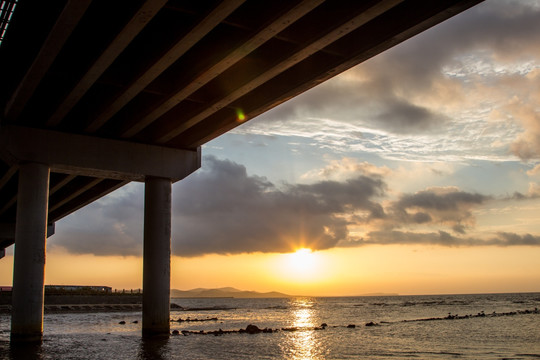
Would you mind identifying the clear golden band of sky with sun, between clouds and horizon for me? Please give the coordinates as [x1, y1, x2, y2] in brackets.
[0, 245, 540, 296]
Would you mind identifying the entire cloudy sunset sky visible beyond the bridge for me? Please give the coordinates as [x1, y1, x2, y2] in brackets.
[0, 0, 540, 296]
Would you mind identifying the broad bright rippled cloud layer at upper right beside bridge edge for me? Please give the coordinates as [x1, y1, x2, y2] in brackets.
[235, 1, 540, 161]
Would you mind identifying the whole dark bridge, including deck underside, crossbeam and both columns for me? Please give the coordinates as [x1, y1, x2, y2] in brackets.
[0, 0, 481, 341]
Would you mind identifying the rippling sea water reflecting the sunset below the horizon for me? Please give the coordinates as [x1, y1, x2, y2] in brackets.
[0, 293, 540, 359]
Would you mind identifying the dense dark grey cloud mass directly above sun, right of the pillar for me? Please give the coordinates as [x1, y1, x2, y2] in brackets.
[173, 157, 384, 256]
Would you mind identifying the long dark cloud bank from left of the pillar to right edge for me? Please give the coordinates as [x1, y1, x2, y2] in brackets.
[49, 156, 540, 257]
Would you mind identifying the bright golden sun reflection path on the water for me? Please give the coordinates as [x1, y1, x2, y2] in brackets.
[287, 298, 324, 360]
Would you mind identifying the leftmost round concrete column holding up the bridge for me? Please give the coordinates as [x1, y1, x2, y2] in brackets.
[11, 163, 49, 342]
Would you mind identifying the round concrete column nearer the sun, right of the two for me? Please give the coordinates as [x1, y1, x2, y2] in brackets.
[142, 177, 172, 337]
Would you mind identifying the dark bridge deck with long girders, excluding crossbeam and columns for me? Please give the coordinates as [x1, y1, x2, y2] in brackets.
[0, 0, 481, 249]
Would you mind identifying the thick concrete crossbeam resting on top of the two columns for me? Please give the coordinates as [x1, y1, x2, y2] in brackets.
[0, 125, 201, 182]
